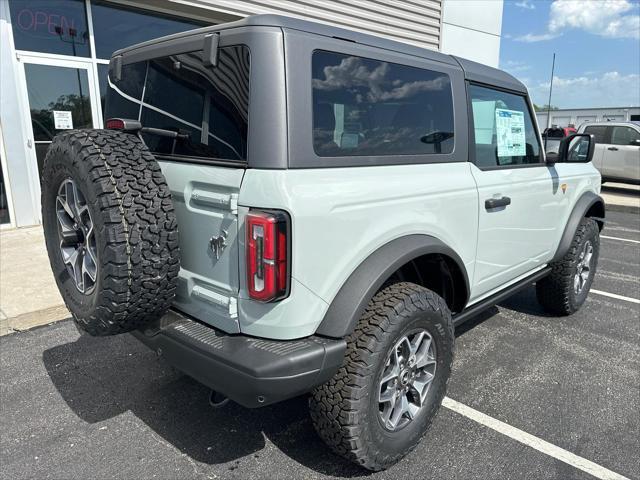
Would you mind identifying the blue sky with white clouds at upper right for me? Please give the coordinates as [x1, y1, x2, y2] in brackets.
[500, 0, 640, 108]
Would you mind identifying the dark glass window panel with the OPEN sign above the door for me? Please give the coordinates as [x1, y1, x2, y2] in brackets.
[9, 0, 91, 57]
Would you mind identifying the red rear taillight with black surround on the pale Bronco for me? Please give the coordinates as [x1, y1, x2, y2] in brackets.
[245, 210, 290, 302]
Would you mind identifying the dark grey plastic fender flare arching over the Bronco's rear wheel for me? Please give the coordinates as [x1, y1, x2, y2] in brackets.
[316, 235, 469, 338]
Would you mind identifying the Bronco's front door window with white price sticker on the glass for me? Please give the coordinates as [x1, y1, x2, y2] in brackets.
[469, 85, 542, 167]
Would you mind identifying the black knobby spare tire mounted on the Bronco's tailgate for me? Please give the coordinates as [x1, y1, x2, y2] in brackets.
[42, 130, 180, 335]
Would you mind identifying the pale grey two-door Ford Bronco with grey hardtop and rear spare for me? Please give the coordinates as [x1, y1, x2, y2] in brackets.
[42, 15, 605, 470]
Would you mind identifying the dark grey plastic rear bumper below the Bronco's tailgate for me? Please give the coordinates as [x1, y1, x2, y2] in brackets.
[133, 311, 346, 408]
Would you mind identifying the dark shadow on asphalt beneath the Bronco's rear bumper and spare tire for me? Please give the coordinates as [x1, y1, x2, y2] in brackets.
[43, 335, 368, 478]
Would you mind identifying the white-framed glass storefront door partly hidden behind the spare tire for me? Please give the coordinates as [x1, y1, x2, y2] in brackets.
[20, 56, 100, 182]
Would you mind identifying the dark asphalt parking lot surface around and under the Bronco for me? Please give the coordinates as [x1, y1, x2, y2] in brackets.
[0, 212, 640, 480]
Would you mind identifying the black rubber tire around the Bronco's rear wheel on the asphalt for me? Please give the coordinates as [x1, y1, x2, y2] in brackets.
[309, 282, 454, 471]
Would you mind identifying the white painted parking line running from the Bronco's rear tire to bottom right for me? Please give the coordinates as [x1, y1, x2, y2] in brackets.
[442, 397, 629, 480]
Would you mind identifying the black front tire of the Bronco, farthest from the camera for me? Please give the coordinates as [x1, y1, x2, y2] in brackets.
[536, 218, 600, 315]
